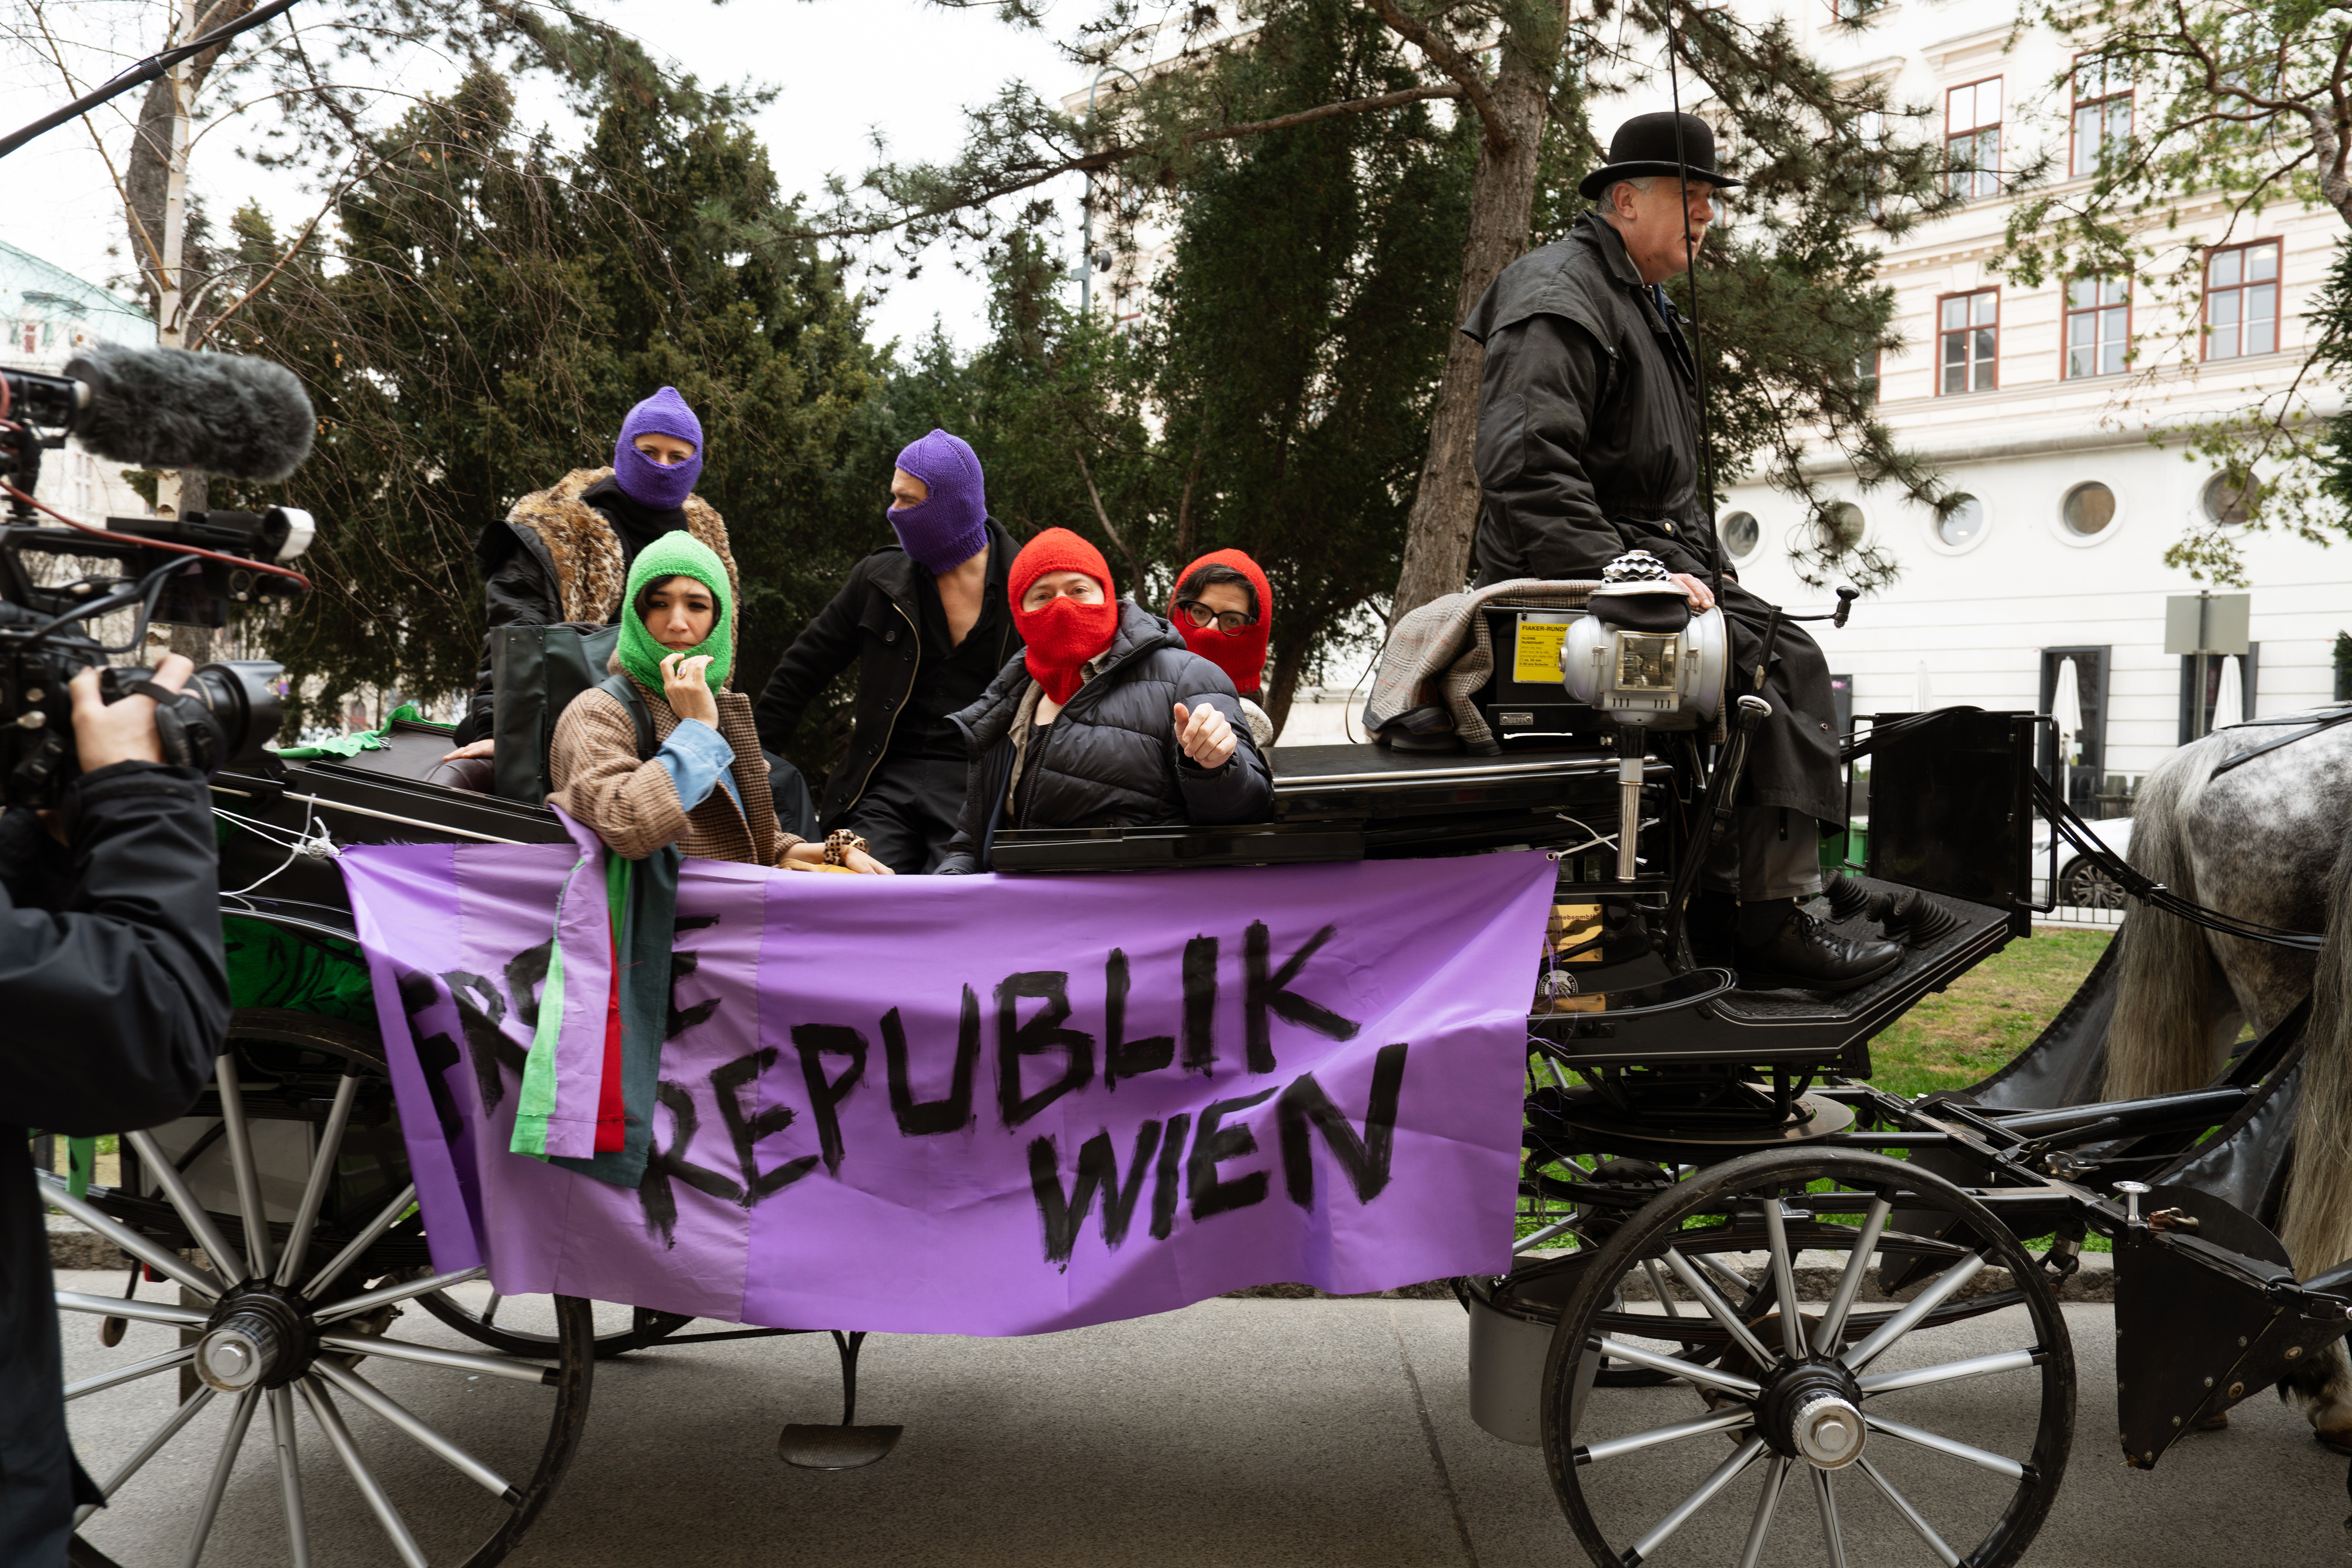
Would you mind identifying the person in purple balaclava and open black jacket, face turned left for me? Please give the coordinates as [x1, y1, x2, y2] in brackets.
[755, 430, 1021, 872]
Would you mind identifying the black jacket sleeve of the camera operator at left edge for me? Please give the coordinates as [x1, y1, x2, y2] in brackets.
[0, 762, 228, 1135]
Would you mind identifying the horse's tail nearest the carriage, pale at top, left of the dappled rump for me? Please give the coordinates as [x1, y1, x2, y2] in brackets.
[2105, 743, 2216, 1100]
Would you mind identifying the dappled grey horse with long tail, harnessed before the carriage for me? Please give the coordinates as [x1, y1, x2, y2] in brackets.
[2105, 724, 2352, 1448]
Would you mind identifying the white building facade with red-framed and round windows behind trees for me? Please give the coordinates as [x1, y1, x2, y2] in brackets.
[1722, 0, 2352, 808]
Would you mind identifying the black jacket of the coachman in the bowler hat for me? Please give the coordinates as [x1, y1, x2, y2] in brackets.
[1463, 212, 1712, 588]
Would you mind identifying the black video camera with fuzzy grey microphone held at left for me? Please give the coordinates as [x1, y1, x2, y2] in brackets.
[0, 346, 315, 806]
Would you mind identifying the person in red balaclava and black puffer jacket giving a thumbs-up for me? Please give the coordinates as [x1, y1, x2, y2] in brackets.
[938, 529, 1275, 877]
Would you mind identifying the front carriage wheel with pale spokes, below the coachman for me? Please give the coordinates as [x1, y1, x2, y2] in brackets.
[1543, 1149, 2074, 1568]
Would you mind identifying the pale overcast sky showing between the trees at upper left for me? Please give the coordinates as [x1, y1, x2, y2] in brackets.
[0, 0, 1089, 348]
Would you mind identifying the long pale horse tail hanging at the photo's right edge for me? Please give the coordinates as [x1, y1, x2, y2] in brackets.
[2277, 827, 2352, 1279]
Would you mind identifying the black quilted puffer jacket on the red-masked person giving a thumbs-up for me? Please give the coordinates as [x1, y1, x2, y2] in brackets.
[938, 600, 1275, 877]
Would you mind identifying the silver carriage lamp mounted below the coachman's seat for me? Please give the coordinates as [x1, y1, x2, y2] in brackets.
[1559, 550, 1731, 881]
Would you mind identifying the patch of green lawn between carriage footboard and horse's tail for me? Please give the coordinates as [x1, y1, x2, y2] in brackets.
[1870, 931, 2114, 1095]
